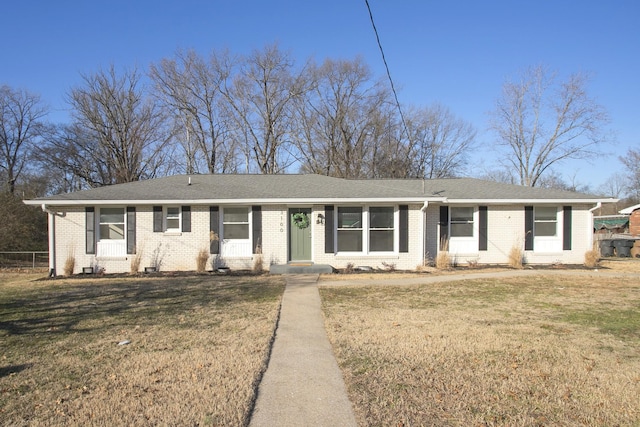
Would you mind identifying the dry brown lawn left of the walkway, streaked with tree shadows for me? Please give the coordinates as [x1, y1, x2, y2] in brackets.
[0, 274, 284, 426]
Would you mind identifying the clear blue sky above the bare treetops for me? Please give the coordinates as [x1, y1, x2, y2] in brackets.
[0, 0, 640, 191]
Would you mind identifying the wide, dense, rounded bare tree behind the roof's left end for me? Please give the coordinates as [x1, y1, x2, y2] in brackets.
[54, 66, 171, 187]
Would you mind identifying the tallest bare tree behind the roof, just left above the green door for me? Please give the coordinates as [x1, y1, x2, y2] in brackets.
[223, 45, 307, 174]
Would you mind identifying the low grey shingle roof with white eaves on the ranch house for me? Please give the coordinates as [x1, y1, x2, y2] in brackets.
[28, 175, 605, 204]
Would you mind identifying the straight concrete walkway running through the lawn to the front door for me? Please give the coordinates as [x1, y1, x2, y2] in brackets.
[249, 275, 356, 427]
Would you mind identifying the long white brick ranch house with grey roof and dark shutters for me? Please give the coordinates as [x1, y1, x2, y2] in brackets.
[25, 175, 615, 274]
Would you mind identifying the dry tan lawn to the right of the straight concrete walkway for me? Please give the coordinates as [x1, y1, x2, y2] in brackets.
[321, 272, 640, 426]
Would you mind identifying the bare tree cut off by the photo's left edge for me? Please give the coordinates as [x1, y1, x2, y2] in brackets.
[0, 85, 47, 194]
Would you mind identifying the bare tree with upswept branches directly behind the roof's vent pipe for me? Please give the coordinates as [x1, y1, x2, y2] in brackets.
[149, 51, 235, 173]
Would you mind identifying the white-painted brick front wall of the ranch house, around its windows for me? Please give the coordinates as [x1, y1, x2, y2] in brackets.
[51, 204, 592, 274]
